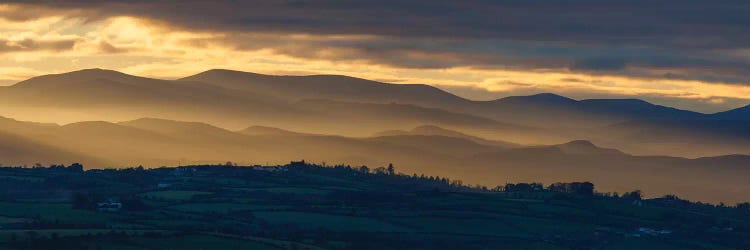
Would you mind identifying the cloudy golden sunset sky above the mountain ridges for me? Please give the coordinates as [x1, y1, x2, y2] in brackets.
[0, 0, 750, 112]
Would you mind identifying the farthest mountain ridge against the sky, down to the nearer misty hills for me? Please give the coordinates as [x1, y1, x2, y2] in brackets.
[5, 69, 750, 157]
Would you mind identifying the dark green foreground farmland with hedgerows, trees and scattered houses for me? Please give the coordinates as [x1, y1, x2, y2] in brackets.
[0, 162, 750, 250]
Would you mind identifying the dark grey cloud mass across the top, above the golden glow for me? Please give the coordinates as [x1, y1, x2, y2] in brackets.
[11, 0, 750, 83]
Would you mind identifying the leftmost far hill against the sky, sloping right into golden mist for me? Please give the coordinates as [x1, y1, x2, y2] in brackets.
[0, 69, 312, 126]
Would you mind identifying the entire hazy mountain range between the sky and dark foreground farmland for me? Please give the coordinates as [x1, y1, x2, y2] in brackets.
[0, 69, 750, 201]
